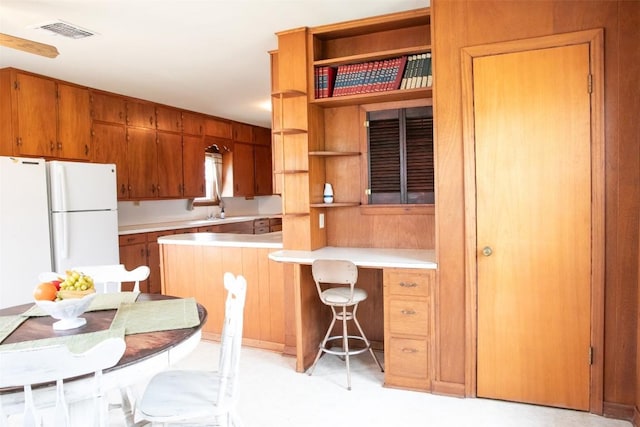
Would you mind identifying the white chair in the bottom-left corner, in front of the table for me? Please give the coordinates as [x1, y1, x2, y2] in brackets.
[0, 338, 126, 427]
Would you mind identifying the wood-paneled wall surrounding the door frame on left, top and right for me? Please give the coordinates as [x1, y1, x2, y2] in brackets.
[432, 0, 640, 413]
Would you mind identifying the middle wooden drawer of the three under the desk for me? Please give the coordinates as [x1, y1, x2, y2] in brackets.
[389, 298, 429, 336]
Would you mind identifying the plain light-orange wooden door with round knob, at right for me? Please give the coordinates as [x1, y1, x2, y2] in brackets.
[473, 43, 592, 410]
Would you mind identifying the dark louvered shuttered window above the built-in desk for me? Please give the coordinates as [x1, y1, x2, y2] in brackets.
[367, 107, 435, 204]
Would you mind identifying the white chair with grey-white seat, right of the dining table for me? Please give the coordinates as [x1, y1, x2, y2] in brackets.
[137, 273, 247, 426]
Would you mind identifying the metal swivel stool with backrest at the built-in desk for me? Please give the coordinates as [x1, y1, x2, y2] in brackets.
[308, 259, 384, 390]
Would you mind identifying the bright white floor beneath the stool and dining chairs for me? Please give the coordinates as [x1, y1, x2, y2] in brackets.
[162, 341, 631, 427]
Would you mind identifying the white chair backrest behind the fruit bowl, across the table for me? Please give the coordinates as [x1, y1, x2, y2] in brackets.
[73, 264, 151, 293]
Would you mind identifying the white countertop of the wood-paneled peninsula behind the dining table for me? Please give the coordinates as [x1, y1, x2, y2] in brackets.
[158, 231, 282, 249]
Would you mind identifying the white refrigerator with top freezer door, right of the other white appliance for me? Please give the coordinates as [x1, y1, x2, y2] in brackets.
[47, 161, 120, 273]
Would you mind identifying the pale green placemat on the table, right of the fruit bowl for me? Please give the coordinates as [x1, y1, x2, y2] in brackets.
[111, 298, 200, 335]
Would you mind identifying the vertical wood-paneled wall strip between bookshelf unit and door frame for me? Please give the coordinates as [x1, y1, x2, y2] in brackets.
[431, 1, 475, 396]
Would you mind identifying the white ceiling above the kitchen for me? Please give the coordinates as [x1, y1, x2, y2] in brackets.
[0, 0, 430, 127]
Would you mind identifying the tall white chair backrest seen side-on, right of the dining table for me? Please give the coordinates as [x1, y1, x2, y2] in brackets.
[217, 273, 247, 407]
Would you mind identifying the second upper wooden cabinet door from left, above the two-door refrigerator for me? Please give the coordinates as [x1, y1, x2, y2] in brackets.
[57, 83, 91, 160]
